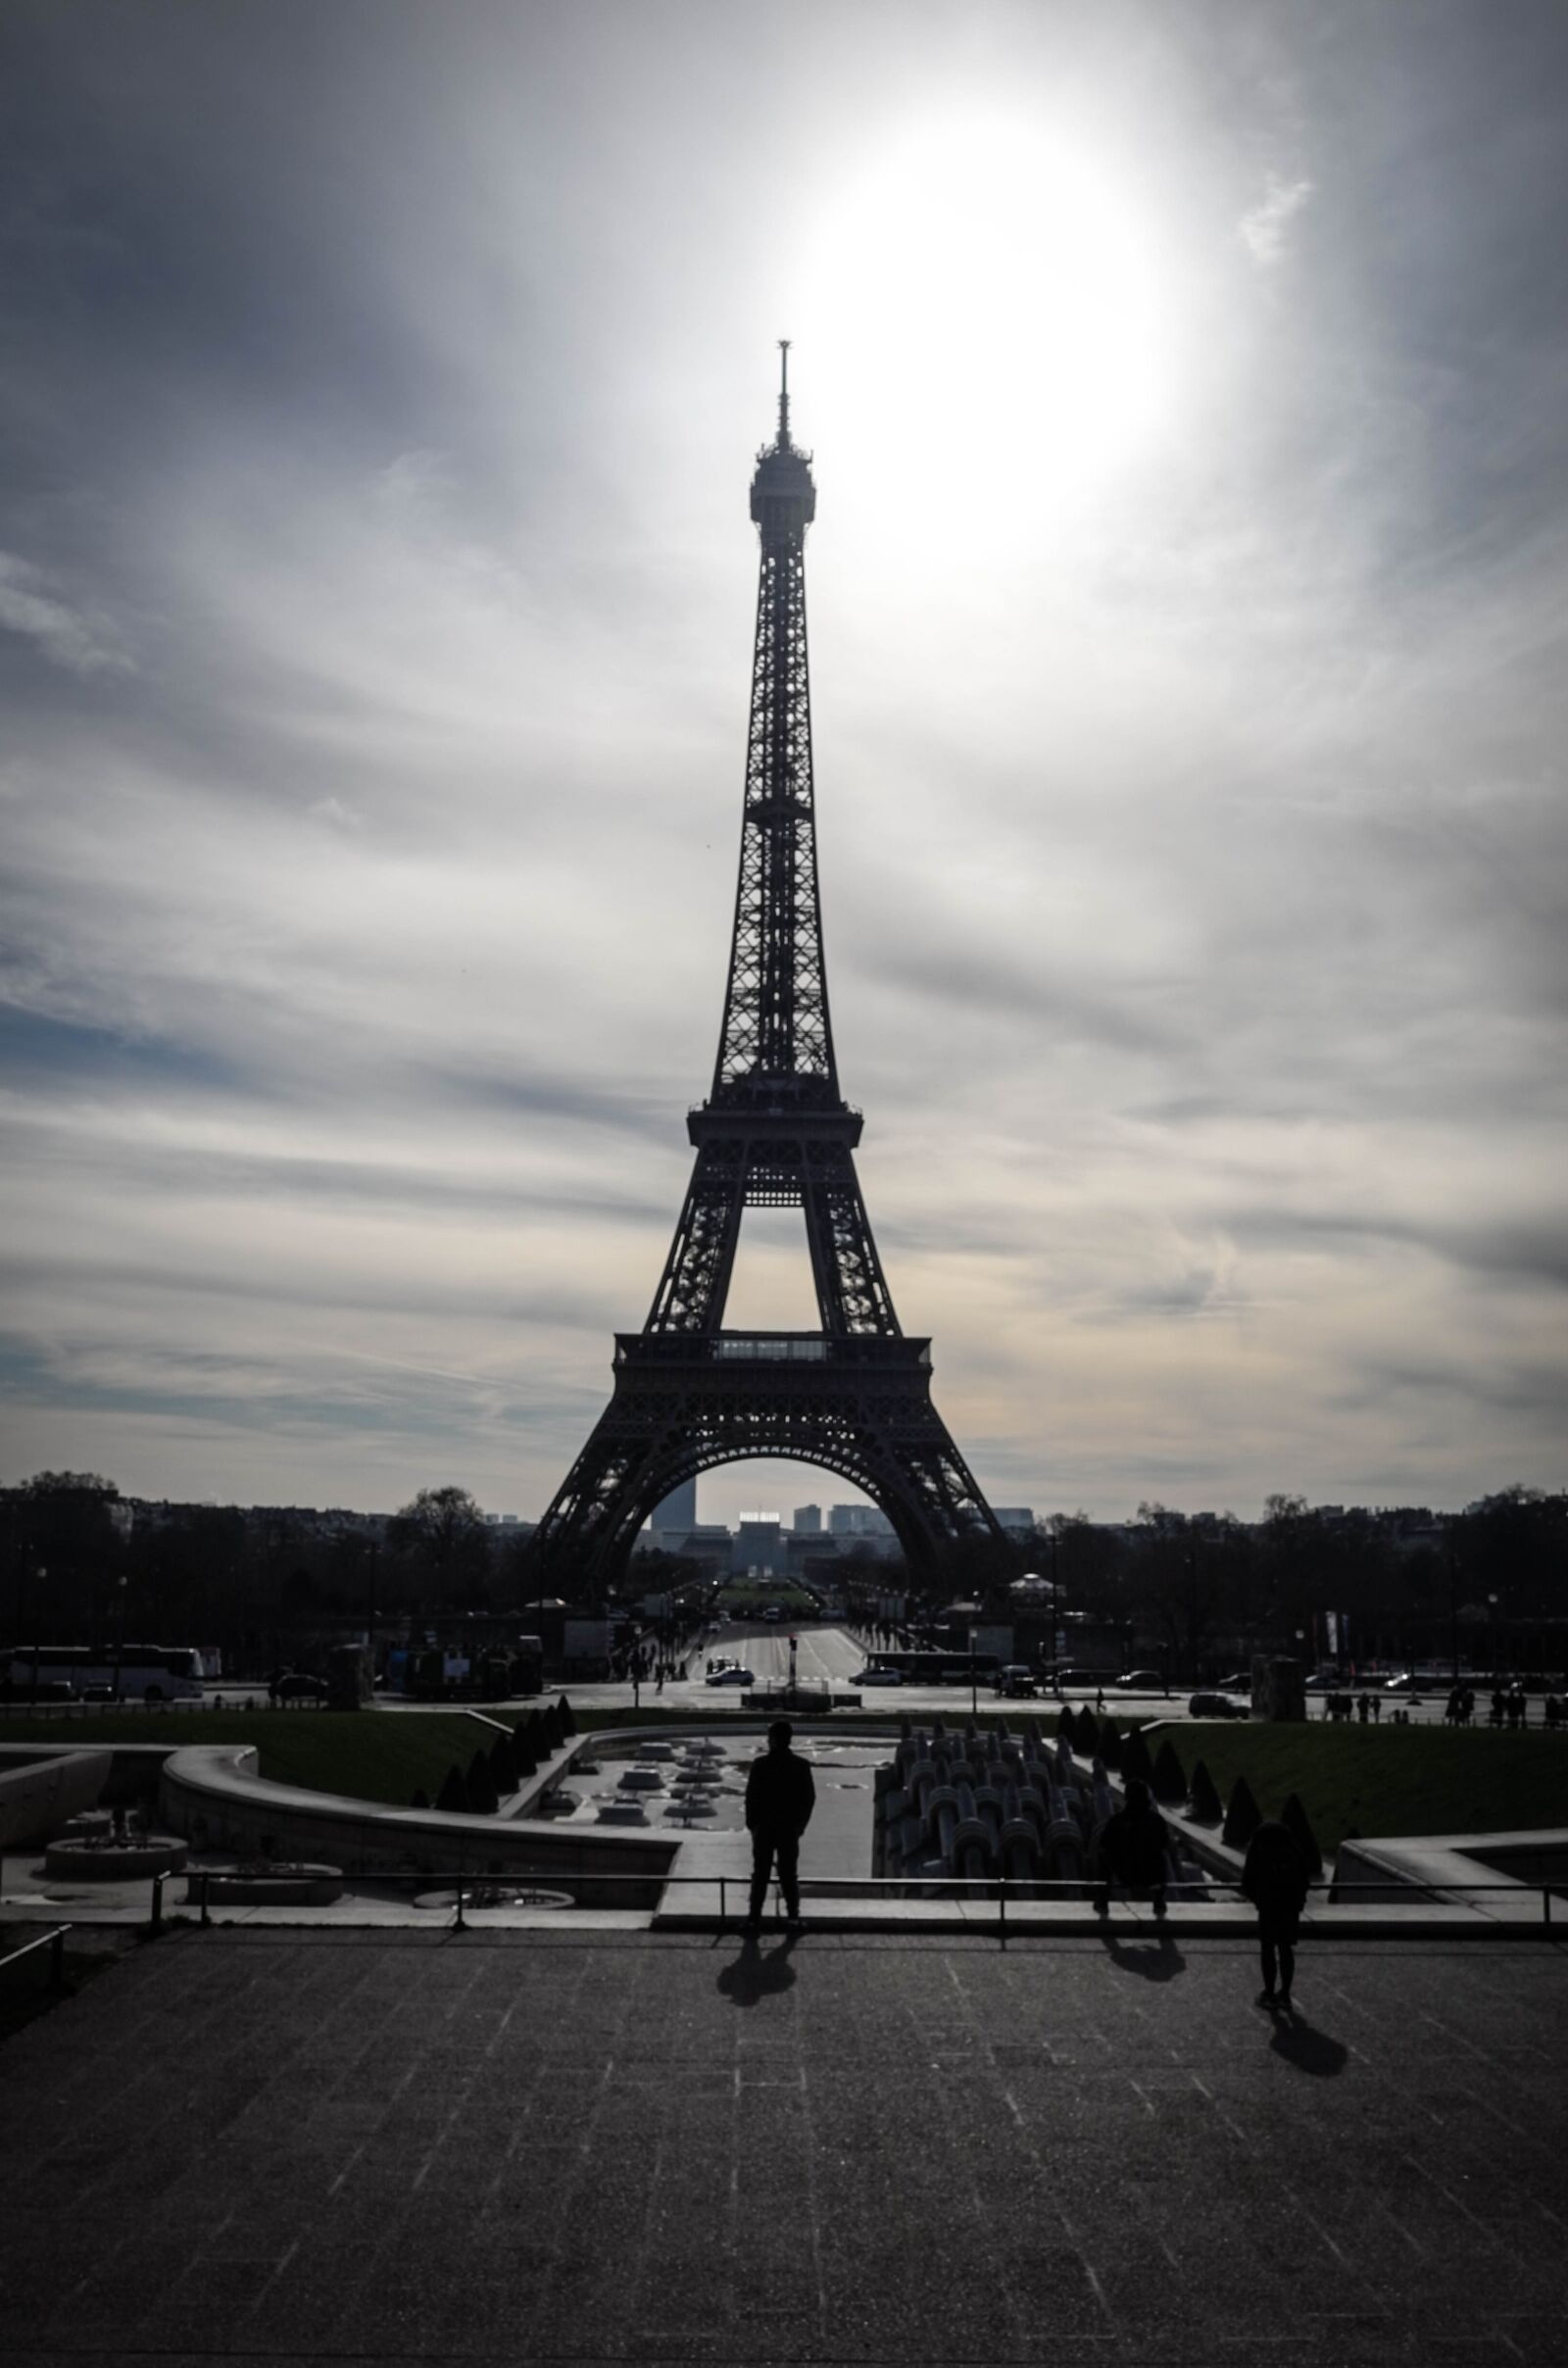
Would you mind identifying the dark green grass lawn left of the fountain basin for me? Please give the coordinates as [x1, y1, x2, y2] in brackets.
[0, 1709, 512, 1806]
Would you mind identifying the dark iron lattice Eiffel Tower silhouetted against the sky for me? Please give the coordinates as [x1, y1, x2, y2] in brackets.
[533, 338, 1002, 1594]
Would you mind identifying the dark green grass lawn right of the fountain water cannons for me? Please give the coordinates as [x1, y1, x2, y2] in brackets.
[1147, 1719, 1568, 1854]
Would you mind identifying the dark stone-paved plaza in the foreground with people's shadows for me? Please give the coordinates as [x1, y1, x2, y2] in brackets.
[0, 1928, 1568, 2368]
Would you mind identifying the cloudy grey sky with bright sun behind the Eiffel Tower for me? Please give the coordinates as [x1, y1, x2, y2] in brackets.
[0, 0, 1568, 1520]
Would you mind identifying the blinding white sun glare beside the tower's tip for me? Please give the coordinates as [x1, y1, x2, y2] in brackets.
[799, 119, 1172, 537]
